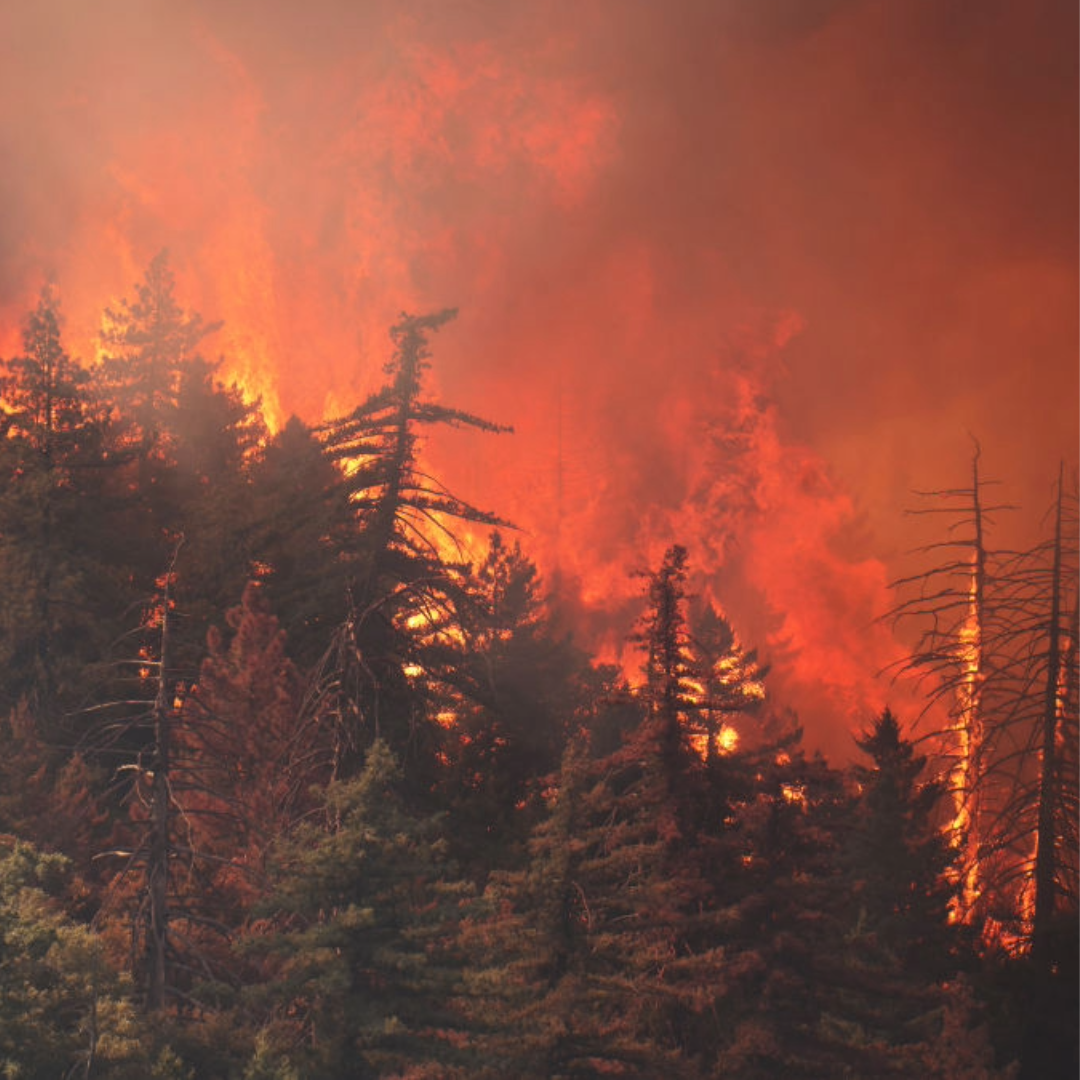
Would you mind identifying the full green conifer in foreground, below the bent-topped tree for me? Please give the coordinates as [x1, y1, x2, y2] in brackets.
[240, 741, 462, 1080]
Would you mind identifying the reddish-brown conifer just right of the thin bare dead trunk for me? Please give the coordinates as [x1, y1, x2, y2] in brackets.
[157, 583, 329, 998]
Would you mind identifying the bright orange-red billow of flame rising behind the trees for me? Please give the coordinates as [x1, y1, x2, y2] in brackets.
[0, 5, 954, 756]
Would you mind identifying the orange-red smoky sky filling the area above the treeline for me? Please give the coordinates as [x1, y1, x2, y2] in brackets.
[0, 0, 1078, 753]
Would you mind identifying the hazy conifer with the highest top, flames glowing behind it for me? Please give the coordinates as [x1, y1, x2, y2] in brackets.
[94, 252, 266, 660]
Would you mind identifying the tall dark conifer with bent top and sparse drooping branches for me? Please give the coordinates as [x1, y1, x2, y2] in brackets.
[320, 310, 508, 788]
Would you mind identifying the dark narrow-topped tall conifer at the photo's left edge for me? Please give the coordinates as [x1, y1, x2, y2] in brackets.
[0, 286, 116, 717]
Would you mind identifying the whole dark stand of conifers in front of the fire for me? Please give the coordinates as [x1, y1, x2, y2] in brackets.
[0, 256, 1080, 1080]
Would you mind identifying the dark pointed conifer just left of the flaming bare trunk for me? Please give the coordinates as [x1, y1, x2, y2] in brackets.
[819, 710, 971, 1076]
